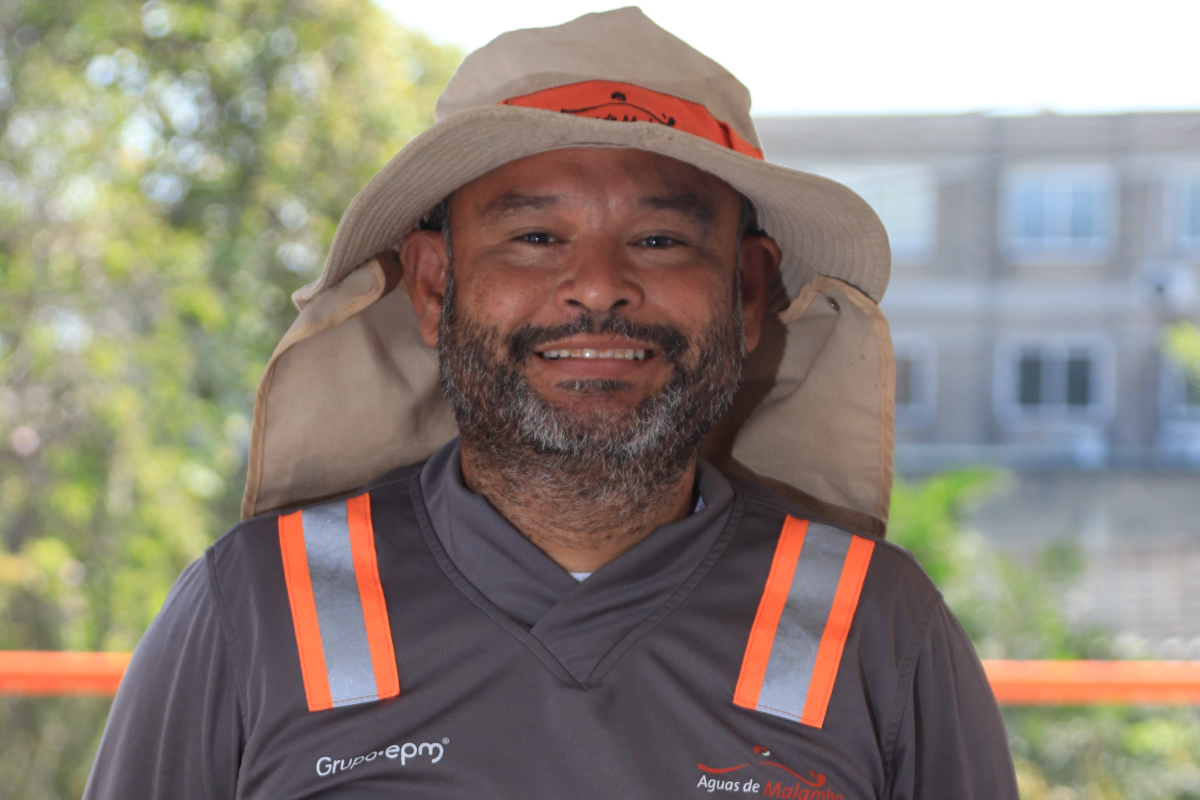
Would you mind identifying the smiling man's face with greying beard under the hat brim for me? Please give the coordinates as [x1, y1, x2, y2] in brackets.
[402, 148, 777, 499]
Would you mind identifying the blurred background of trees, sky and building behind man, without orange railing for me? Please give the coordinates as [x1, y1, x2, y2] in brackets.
[0, 0, 1200, 800]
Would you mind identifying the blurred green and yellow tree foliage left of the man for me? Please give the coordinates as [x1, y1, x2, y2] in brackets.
[0, 0, 460, 799]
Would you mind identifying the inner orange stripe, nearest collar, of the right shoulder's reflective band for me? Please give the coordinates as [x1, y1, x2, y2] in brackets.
[733, 517, 809, 709]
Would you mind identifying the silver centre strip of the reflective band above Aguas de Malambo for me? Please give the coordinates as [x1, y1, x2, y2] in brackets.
[758, 523, 851, 720]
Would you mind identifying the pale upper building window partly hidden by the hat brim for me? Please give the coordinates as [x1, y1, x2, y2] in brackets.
[799, 164, 937, 263]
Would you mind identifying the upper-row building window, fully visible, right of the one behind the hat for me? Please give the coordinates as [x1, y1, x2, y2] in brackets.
[1002, 164, 1116, 259]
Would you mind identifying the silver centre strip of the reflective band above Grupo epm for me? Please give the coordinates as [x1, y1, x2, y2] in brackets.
[304, 503, 379, 706]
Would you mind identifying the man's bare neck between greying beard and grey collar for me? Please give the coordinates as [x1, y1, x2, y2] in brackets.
[462, 441, 696, 572]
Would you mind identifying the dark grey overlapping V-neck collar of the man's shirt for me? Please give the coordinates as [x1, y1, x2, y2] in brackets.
[413, 439, 734, 685]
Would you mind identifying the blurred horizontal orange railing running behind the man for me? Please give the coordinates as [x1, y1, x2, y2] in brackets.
[0, 650, 1200, 705]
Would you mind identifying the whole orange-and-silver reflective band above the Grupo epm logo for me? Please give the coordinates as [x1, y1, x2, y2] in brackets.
[280, 494, 400, 711]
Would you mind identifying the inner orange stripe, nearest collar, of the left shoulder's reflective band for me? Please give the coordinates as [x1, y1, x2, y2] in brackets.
[346, 494, 400, 699]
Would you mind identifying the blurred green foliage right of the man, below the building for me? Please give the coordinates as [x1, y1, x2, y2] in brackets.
[888, 471, 1200, 800]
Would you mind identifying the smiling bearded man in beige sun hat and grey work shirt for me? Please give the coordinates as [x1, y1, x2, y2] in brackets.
[86, 8, 1016, 800]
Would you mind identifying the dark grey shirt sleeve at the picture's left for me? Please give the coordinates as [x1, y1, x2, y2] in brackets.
[83, 558, 245, 800]
